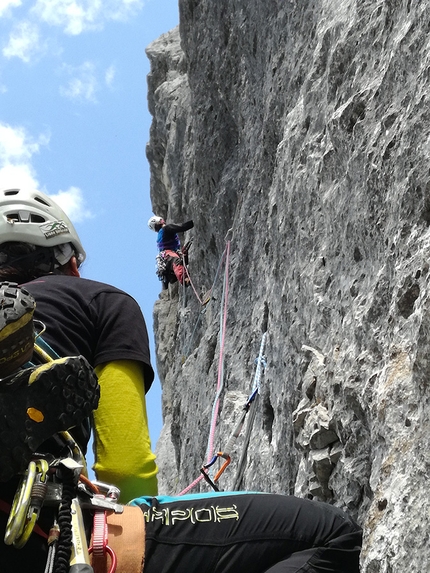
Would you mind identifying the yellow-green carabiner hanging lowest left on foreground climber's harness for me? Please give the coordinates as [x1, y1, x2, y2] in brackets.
[4, 459, 49, 549]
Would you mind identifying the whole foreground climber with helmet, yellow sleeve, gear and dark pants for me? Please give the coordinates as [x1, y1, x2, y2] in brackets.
[0, 189, 362, 573]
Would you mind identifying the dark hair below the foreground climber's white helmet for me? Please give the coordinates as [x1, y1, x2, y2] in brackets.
[0, 242, 70, 284]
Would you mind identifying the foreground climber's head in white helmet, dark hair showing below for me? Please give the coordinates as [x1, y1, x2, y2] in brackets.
[0, 188, 85, 283]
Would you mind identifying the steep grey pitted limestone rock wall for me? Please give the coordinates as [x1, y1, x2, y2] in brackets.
[148, 0, 430, 573]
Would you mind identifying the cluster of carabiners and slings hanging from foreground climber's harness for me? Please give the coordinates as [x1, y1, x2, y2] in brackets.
[0, 432, 124, 573]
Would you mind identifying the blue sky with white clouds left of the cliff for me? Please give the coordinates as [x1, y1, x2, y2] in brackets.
[0, 0, 179, 458]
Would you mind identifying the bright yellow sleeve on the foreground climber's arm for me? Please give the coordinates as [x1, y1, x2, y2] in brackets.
[93, 360, 158, 503]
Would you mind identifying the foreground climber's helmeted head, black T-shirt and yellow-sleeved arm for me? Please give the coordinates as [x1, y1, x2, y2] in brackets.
[0, 188, 158, 500]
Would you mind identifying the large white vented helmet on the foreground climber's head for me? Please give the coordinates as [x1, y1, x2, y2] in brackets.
[0, 188, 86, 264]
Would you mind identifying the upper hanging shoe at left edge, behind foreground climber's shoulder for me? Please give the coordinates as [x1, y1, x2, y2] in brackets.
[0, 282, 36, 378]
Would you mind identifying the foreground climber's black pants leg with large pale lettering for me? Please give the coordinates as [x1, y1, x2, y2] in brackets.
[133, 492, 362, 573]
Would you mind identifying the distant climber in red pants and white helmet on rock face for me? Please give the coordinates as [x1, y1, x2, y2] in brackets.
[148, 215, 194, 289]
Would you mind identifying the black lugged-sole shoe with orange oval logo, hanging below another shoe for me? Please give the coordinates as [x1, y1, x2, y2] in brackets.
[0, 356, 100, 482]
